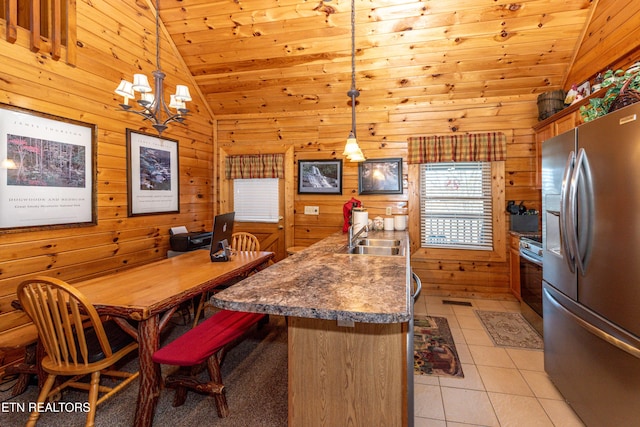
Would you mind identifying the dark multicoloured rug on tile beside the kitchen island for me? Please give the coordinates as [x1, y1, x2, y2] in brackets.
[413, 316, 464, 378]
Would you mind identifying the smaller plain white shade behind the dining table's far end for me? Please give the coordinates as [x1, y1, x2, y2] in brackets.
[233, 178, 280, 223]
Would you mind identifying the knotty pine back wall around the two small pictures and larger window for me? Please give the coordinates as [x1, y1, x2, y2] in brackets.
[216, 92, 541, 296]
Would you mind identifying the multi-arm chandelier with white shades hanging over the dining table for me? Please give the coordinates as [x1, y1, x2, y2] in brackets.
[115, 0, 191, 134]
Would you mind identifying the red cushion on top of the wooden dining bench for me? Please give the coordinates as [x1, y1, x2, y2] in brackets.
[153, 310, 265, 366]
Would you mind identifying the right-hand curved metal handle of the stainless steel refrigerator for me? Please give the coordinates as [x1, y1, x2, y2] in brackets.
[572, 148, 593, 276]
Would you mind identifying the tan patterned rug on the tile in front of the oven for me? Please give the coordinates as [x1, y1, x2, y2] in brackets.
[476, 310, 544, 350]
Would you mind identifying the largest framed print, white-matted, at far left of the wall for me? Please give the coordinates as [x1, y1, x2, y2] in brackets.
[0, 104, 97, 232]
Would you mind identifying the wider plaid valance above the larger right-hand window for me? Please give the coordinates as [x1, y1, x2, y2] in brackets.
[408, 132, 507, 164]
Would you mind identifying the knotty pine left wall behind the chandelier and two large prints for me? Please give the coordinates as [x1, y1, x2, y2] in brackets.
[0, 0, 214, 373]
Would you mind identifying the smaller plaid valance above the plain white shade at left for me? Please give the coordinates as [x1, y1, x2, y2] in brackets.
[224, 154, 284, 179]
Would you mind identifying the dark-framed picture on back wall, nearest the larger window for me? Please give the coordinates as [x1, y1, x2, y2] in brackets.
[358, 158, 402, 194]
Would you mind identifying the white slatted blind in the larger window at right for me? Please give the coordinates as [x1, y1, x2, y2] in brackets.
[420, 162, 493, 250]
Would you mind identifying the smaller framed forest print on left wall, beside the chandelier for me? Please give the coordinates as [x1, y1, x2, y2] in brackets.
[127, 129, 180, 216]
